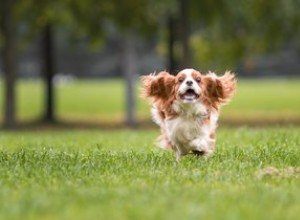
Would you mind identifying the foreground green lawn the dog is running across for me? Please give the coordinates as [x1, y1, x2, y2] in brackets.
[0, 127, 300, 220]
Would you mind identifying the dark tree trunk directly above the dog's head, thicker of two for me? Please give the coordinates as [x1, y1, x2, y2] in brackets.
[179, 0, 192, 68]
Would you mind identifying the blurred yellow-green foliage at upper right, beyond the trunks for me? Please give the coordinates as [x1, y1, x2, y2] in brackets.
[190, 0, 300, 69]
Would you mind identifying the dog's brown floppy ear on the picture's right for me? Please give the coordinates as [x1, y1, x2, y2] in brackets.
[203, 71, 236, 108]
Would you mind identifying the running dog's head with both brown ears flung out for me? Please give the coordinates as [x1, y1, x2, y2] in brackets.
[141, 69, 236, 109]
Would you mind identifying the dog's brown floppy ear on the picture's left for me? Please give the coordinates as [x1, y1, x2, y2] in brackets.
[141, 71, 175, 99]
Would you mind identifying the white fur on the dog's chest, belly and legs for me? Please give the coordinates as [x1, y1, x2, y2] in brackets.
[152, 100, 218, 159]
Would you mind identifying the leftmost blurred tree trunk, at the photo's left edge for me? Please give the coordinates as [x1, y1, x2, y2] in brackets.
[1, 0, 16, 128]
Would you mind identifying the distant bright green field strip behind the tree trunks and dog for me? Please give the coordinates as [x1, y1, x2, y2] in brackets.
[0, 79, 300, 124]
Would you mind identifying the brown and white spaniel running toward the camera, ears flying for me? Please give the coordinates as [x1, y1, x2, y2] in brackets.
[141, 69, 236, 159]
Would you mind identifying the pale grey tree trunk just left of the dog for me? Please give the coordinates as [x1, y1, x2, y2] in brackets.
[121, 33, 137, 128]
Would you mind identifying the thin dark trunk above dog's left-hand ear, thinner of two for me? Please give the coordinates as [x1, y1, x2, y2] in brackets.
[168, 15, 176, 74]
